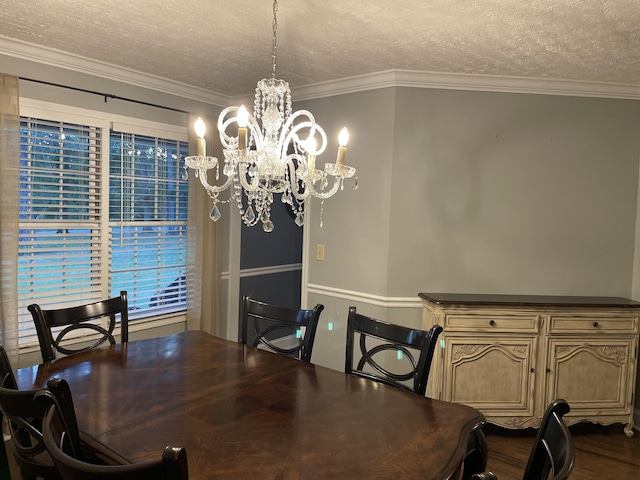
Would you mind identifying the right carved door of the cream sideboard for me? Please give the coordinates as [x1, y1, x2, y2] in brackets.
[546, 337, 635, 416]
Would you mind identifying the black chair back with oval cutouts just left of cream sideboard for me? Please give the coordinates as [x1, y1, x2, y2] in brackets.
[344, 307, 442, 395]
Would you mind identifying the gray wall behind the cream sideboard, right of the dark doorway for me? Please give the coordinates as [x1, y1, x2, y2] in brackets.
[295, 88, 640, 390]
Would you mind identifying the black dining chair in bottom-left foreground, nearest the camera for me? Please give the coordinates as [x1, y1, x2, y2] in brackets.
[36, 378, 189, 480]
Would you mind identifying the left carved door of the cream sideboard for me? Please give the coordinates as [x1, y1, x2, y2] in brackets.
[443, 335, 537, 417]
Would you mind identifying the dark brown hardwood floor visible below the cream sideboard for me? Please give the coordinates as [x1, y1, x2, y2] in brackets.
[484, 423, 640, 480]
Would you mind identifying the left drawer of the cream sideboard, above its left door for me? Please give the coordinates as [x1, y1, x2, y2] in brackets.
[444, 314, 539, 332]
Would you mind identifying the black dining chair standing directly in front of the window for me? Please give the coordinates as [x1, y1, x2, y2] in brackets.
[27, 291, 129, 362]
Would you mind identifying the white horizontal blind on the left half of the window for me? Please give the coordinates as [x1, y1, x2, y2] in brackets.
[18, 117, 103, 345]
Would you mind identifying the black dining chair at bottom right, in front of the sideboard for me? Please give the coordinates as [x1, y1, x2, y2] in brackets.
[471, 399, 576, 480]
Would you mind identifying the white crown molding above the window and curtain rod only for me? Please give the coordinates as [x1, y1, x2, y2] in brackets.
[0, 35, 231, 107]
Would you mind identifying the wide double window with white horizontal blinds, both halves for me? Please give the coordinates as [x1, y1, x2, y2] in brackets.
[18, 110, 187, 346]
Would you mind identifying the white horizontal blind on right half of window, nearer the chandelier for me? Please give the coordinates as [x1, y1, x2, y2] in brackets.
[109, 131, 188, 319]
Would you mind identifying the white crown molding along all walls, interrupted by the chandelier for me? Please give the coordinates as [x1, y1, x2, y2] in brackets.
[0, 35, 640, 107]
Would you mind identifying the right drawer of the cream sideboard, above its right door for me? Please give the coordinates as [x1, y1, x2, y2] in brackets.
[548, 315, 638, 334]
